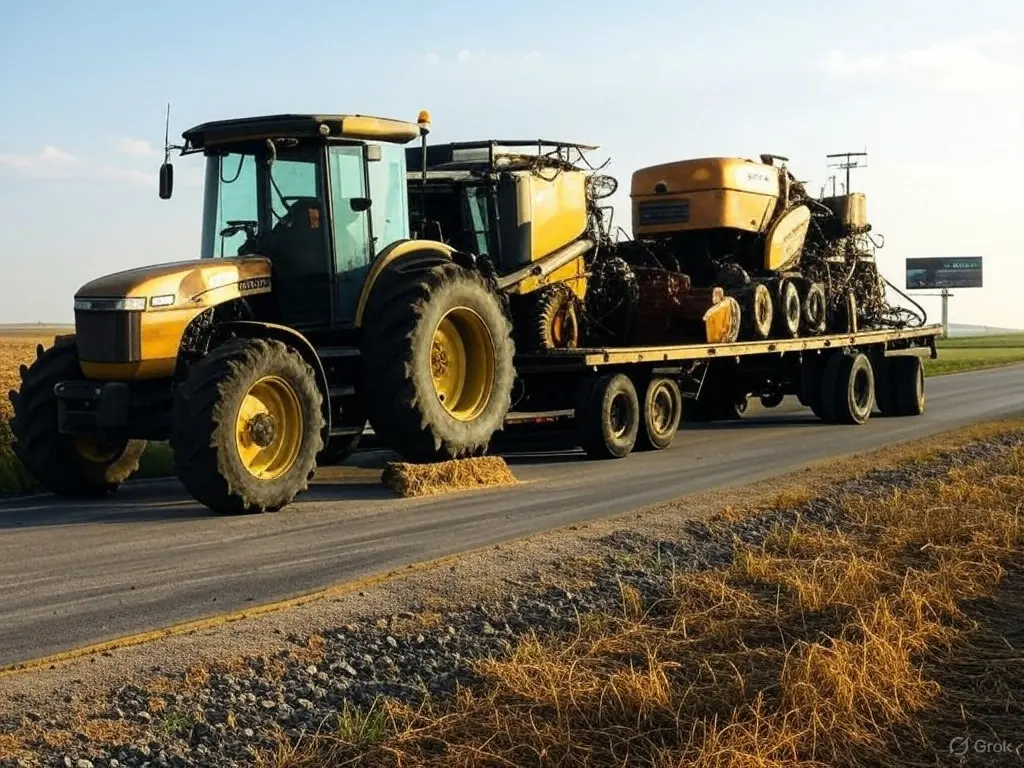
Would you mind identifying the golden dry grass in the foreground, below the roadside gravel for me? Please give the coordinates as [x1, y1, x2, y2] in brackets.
[261, 438, 1024, 768]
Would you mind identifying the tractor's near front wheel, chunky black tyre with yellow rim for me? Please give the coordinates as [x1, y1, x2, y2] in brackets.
[171, 339, 324, 514]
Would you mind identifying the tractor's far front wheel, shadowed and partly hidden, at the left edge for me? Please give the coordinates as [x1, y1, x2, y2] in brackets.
[9, 337, 146, 498]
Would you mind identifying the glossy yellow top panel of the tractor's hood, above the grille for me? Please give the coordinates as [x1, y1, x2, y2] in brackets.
[75, 256, 270, 310]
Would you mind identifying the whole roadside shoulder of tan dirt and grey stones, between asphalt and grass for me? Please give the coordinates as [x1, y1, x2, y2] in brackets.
[0, 418, 1024, 768]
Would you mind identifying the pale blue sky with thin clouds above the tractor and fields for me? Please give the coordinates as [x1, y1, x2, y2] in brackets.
[0, 0, 1024, 328]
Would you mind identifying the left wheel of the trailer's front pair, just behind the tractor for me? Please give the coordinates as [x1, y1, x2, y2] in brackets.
[575, 374, 640, 459]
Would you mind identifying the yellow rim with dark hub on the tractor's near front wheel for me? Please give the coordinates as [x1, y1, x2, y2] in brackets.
[234, 376, 304, 480]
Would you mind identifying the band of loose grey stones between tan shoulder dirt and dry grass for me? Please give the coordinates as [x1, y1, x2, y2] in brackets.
[0, 433, 1024, 768]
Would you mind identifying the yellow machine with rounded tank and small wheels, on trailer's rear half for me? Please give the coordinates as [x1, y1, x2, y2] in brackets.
[594, 155, 890, 348]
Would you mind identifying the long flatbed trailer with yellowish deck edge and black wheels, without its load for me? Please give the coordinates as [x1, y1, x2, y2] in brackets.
[495, 325, 942, 459]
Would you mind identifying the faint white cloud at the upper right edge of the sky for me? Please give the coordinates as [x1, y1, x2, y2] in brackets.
[824, 33, 1024, 91]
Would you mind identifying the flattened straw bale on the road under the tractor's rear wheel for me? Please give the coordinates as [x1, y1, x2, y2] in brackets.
[381, 456, 518, 497]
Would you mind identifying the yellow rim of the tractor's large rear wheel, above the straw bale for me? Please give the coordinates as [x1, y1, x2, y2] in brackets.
[430, 307, 495, 421]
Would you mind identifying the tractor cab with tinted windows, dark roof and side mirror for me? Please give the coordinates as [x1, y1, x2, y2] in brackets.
[161, 113, 429, 332]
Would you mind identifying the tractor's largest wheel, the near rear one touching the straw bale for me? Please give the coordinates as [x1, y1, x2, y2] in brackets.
[362, 262, 515, 462]
